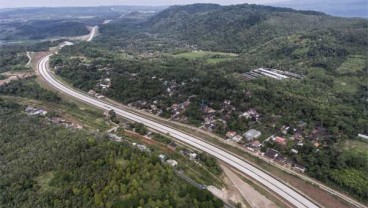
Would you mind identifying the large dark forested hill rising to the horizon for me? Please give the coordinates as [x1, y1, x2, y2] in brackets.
[147, 4, 367, 52]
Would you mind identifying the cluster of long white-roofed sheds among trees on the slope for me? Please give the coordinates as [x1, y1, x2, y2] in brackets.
[241, 68, 303, 80]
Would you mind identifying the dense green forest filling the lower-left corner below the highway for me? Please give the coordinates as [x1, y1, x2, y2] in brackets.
[0, 98, 223, 207]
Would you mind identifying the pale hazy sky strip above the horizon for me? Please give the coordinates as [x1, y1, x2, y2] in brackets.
[0, 0, 368, 18]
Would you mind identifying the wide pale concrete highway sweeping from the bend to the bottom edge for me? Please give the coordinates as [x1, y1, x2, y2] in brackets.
[38, 55, 318, 208]
